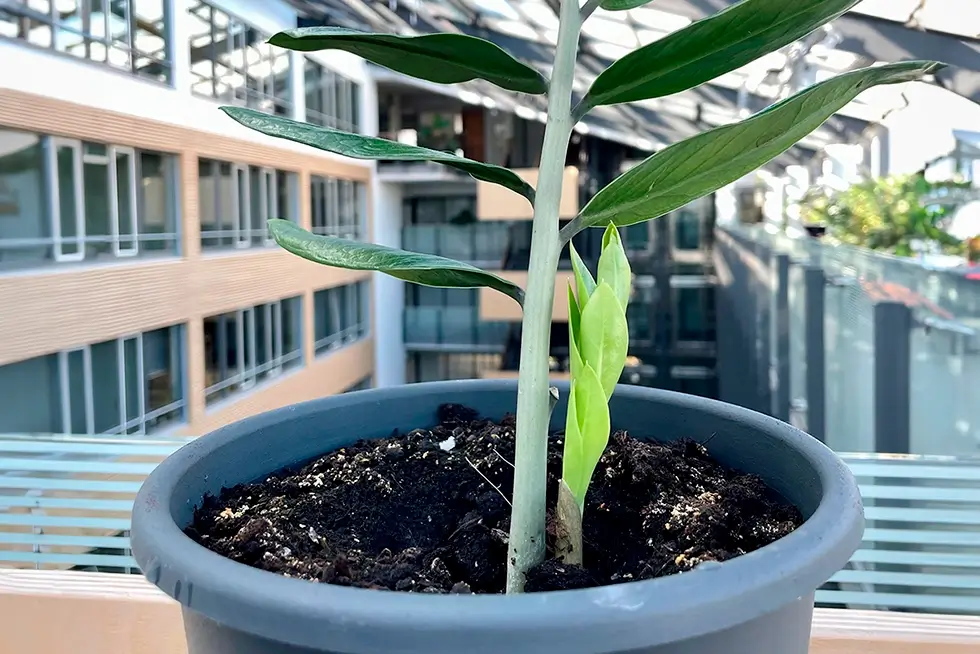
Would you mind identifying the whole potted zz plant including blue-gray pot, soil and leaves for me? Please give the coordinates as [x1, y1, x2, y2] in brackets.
[132, 0, 937, 654]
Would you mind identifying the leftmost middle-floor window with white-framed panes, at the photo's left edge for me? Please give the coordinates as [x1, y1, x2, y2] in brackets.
[0, 130, 177, 270]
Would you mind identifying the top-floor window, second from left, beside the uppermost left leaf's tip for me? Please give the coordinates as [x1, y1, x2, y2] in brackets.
[188, 0, 292, 116]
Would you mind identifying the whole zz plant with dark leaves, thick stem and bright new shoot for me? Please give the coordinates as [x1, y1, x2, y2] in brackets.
[223, 0, 941, 592]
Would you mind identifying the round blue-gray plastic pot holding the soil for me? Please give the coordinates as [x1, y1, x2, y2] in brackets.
[132, 381, 864, 654]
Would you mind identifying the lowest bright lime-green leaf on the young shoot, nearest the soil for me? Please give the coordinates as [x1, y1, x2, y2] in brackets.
[561, 364, 609, 512]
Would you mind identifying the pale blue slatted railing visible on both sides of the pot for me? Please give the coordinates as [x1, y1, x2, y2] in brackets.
[0, 435, 980, 613]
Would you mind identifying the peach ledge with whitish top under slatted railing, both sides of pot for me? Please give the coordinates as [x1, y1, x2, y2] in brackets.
[0, 571, 980, 654]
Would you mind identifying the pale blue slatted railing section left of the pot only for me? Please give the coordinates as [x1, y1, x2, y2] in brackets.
[0, 434, 189, 572]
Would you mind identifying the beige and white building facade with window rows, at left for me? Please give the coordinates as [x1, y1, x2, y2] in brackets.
[0, 0, 376, 434]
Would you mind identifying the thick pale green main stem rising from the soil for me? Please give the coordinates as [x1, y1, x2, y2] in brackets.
[507, 0, 582, 593]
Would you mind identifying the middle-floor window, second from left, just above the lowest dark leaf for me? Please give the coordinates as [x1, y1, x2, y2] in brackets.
[198, 159, 297, 249]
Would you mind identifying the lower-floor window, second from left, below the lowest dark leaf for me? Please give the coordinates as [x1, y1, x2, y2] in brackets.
[204, 297, 303, 404]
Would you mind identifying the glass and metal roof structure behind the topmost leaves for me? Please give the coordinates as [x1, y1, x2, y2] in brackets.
[291, 0, 980, 161]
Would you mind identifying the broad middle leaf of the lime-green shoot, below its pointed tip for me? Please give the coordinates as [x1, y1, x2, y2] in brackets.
[573, 282, 629, 399]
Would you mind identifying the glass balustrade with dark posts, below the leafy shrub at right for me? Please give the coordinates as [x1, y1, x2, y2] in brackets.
[715, 226, 980, 456]
